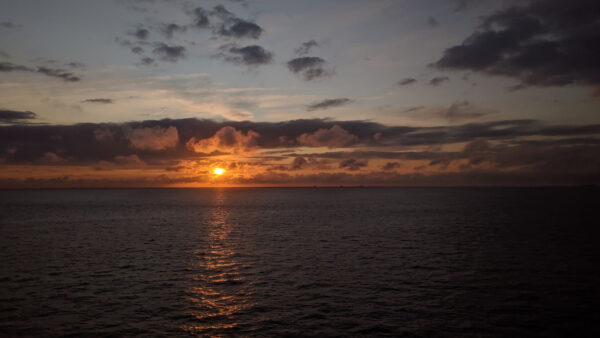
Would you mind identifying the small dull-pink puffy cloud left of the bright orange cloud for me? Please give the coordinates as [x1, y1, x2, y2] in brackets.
[128, 126, 179, 150]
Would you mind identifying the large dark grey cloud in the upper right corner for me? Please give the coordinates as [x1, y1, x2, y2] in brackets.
[435, 0, 600, 86]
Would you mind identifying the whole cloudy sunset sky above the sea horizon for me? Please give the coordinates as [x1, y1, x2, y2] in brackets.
[0, 0, 600, 188]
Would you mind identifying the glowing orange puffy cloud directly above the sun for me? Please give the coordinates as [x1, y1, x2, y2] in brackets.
[186, 126, 260, 154]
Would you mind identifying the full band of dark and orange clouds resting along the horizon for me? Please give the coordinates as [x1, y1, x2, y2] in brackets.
[0, 119, 600, 187]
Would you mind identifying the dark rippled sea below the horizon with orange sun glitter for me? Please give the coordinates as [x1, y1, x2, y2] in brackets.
[0, 188, 600, 337]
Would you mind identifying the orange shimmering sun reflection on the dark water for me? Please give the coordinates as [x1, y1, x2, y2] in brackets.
[184, 190, 252, 335]
